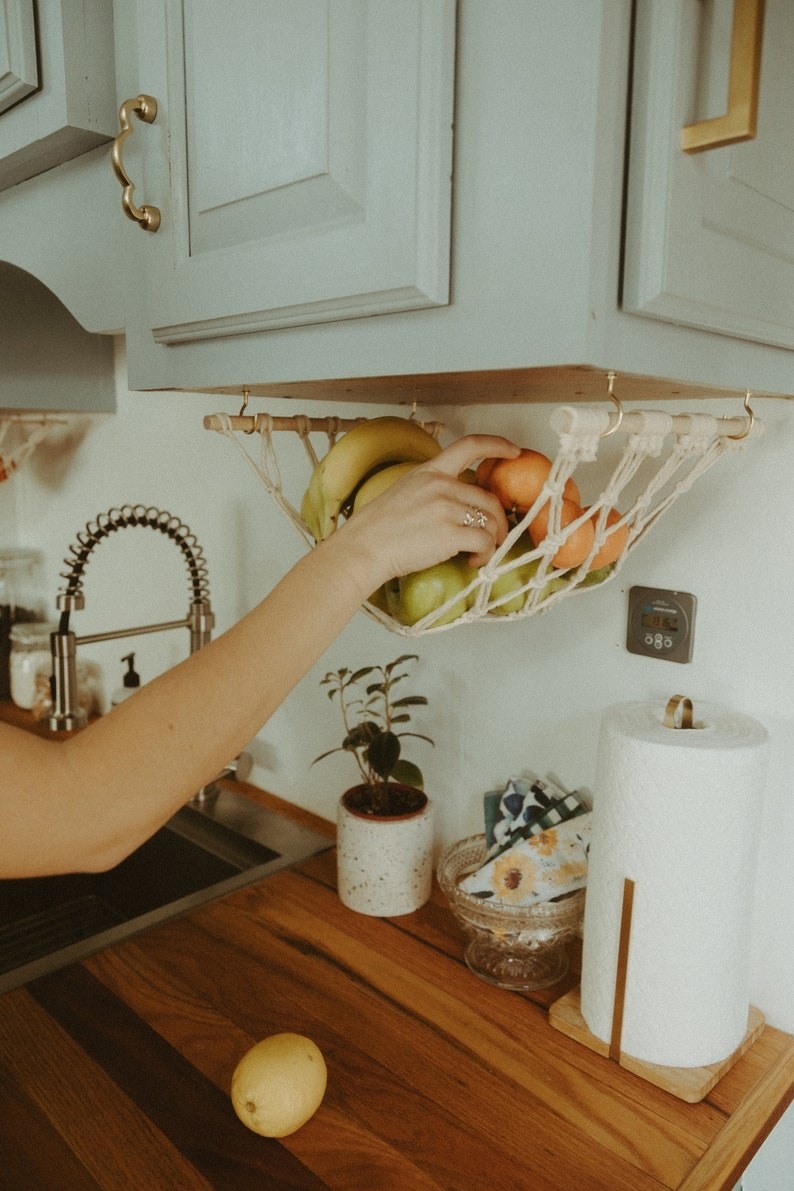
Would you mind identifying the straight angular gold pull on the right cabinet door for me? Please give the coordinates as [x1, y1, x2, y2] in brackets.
[681, 0, 764, 152]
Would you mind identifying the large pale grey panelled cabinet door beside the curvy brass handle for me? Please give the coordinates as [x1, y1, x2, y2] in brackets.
[124, 0, 455, 350]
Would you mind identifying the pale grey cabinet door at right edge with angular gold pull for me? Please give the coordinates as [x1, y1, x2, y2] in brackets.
[623, 0, 794, 348]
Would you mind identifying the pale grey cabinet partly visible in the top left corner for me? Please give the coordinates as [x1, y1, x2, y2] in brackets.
[0, 0, 115, 189]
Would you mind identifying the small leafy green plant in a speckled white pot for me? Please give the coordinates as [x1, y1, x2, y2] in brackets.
[313, 654, 433, 917]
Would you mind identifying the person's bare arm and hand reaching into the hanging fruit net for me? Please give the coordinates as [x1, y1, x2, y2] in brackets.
[0, 435, 518, 877]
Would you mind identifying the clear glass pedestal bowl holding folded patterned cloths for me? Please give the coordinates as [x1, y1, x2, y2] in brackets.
[438, 835, 584, 990]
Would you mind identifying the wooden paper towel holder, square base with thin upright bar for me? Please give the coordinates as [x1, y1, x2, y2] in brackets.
[549, 878, 765, 1104]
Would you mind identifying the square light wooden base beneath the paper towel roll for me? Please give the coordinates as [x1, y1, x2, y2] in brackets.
[549, 989, 765, 1104]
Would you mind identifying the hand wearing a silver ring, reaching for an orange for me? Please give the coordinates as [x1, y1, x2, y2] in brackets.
[333, 435, 519, 590]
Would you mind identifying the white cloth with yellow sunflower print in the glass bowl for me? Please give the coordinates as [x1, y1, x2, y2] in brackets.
[461, 811, 593, 905]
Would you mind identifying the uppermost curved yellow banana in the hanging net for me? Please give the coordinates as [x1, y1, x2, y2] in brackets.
[300, 417, 440, 542]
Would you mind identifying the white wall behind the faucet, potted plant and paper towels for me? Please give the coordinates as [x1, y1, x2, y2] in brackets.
[0, 348, 794, 1030]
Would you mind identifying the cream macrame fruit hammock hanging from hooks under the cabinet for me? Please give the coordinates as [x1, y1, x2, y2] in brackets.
[204, 388, 763, 637]
